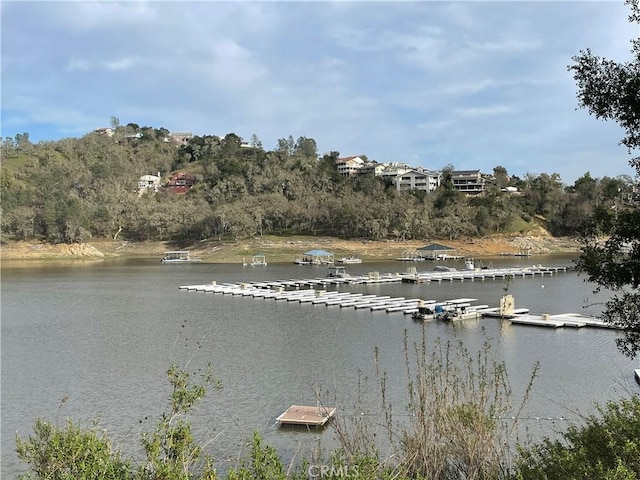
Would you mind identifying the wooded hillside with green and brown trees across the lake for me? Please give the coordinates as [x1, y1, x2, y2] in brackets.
[0, 124, 632, 243]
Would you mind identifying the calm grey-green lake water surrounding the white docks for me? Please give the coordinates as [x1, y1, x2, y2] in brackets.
[1, 257, 640, 478]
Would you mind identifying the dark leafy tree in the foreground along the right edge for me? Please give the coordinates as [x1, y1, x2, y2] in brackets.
[568, 0, 640, 357]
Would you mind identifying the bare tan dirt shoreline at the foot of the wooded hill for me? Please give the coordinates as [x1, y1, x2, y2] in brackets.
[0, 235, 580, 263]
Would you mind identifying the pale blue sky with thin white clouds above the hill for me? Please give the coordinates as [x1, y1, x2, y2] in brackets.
[0, 0, 640, 185]
